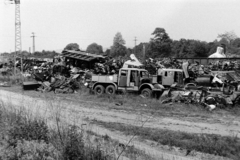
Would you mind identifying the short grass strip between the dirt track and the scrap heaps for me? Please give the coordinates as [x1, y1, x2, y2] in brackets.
[1, 85, 240, 121]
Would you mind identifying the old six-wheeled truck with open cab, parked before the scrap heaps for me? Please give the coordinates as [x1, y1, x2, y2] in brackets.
[88, 68, 164, 98]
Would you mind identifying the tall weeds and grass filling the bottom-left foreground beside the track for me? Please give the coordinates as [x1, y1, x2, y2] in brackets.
[0, 97, 158, 160]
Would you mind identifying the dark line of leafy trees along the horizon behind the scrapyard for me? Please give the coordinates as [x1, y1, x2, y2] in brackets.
[65, 28, 240, 59]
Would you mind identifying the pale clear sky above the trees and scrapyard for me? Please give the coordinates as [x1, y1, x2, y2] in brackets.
[0, 0, 240, 53]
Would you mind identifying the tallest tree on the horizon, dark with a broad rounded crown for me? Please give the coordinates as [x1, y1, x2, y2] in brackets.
[148, 28, 172, 58]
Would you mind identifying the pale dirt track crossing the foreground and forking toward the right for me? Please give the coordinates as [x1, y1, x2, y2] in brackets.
[0, 90, 237, 160]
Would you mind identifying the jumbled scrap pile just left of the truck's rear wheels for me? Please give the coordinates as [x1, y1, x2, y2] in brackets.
[27, 62, 87, 93]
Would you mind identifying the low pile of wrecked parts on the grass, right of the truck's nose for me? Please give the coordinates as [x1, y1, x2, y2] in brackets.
[161, 82, 240, 111]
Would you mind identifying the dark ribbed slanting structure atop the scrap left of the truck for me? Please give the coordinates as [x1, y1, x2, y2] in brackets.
[62, 50, 105, 69]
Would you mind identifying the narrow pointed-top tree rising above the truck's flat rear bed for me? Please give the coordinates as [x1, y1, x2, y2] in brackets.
[111, 32, 127, 57]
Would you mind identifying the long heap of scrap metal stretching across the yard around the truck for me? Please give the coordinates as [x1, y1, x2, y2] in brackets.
[0, 52, 240, 110]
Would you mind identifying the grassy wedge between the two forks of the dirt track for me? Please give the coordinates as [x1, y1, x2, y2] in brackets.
[92, 120, 240, 160]
